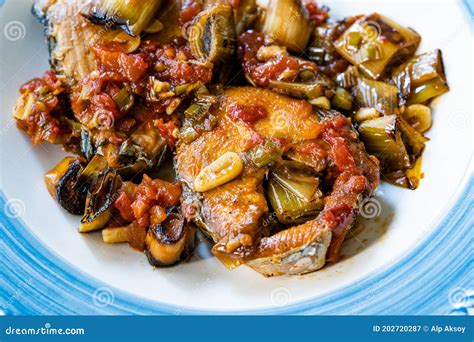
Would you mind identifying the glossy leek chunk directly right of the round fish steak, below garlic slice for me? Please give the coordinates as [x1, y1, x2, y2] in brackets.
[359, 115, 410, 170]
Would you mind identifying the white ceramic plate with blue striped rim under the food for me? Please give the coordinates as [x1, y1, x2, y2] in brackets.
[0, 0, 473, 314]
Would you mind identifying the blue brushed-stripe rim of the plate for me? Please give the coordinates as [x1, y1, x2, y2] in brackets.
[0, 168, 474, 315]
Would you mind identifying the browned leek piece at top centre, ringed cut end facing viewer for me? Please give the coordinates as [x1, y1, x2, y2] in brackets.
[189, 4, 236, 63]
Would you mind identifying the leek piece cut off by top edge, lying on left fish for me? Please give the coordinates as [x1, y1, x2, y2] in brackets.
[84, 0, 162, 36]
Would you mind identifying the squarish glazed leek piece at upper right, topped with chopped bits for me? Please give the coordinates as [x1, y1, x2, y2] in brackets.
[335, 13, 420, 79]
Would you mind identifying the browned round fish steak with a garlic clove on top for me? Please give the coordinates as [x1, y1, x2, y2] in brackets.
[176, 87, 379, 276]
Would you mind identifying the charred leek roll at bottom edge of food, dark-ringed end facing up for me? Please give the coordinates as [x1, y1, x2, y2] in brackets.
[145, 211, 195, 267]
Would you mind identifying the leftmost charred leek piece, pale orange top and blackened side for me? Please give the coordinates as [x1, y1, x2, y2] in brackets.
[44, 157, 87, 215]
